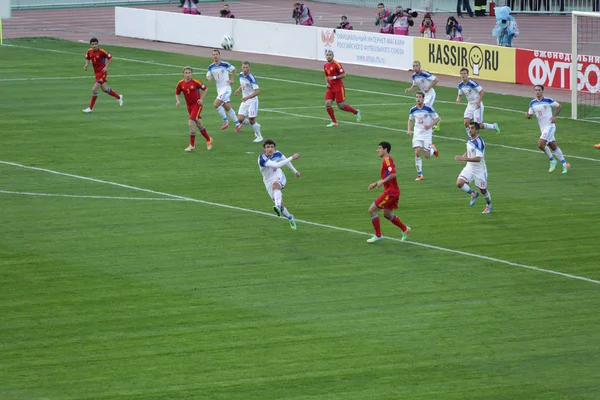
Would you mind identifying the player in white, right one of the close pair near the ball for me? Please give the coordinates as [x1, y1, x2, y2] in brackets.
[234, 61, 263, 143]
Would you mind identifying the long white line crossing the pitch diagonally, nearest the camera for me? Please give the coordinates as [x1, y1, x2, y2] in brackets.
[0, 160, 600, 285]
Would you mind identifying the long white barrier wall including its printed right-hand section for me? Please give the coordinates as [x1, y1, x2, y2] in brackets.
[115, 7, 413, 71]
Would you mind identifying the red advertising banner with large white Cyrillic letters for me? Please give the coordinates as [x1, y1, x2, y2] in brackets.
[515, 49, 600, 93]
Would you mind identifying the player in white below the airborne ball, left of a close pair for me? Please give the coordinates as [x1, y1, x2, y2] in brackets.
[206, 49, 239, 130]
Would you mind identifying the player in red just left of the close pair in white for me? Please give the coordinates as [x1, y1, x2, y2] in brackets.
[175, 67, 212, 151]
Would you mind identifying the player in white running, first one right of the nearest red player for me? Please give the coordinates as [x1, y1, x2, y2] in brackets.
[454, 122, 492, 214]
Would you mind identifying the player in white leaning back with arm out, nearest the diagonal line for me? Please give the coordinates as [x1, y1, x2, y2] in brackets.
[258, 139, 300, 230]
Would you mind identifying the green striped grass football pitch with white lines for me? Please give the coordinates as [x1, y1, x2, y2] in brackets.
[0, 39, 600, 400]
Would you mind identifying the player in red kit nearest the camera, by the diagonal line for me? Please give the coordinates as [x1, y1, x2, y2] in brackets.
[367, 142, 410, 243]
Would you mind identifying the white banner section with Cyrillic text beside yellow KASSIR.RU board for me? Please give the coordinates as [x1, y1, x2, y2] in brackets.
[317, 28, 413, 71]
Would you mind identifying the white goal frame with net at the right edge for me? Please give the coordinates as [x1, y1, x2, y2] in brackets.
[570, 10, 600, 121]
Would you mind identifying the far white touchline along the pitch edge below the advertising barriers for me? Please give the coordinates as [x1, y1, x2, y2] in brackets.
[4, 44, 600, 124]
